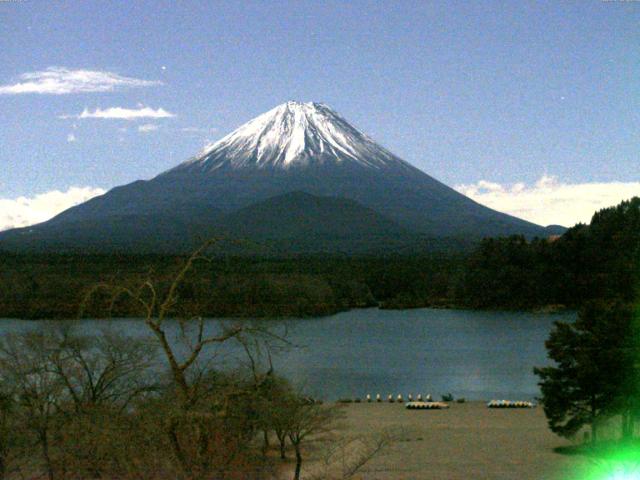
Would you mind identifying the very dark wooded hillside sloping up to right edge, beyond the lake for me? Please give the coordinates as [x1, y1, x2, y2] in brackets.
[458, 197, 640, 308]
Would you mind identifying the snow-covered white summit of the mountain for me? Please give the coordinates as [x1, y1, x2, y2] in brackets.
[174, 102, 409, 171]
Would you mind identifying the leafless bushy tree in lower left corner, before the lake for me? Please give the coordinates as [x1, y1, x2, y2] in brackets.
[0, 324, 160, 479]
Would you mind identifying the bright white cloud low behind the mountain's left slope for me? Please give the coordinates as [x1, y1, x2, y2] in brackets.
[0, 187, 105, 231]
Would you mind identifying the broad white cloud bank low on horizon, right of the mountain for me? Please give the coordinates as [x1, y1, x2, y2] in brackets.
[455, 175, 640, 227]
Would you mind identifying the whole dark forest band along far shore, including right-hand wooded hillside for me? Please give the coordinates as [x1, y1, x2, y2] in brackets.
[0, 197, 640, 319]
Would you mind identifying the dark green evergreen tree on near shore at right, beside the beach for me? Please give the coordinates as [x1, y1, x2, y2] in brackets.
[534, 301, 640, 441]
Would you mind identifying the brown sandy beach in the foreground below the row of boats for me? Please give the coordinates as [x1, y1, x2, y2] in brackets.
[320, 402, 588, 480]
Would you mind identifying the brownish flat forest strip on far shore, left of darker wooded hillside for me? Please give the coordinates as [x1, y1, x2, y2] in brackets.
[0, 253, 462, 319]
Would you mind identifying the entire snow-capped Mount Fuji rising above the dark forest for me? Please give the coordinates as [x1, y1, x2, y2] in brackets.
[0, 102, 557, 253]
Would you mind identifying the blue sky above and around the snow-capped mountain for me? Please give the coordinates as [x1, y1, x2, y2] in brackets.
[0, 0, 640, 229]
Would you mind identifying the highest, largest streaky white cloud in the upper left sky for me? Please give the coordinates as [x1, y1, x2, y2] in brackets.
[0, 67, 162, 95]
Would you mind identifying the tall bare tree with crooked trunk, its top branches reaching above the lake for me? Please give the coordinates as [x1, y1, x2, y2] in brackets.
[81, 239, 282, 478]
